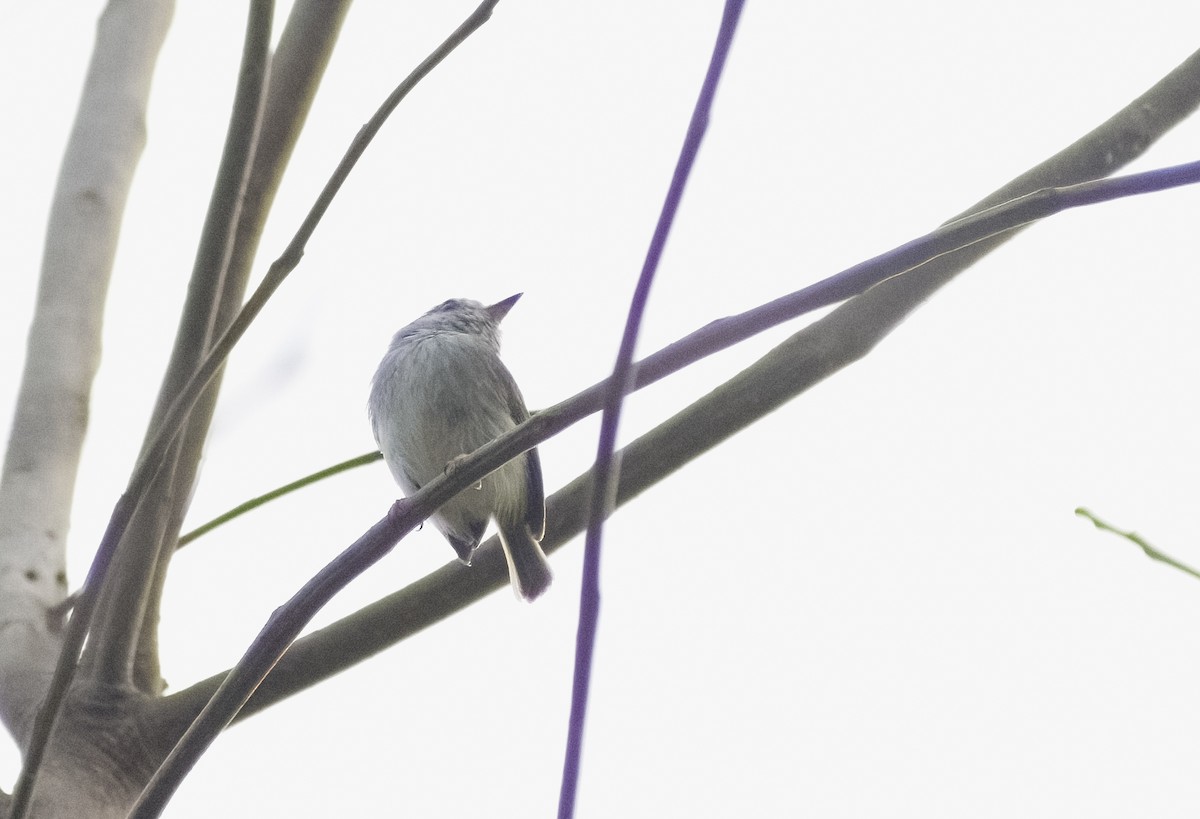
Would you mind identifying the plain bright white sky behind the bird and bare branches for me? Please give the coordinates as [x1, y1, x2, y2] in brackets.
[0, 0, 1200, 818]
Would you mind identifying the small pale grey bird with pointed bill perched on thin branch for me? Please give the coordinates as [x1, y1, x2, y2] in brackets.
[368, 293, 551, 600]
